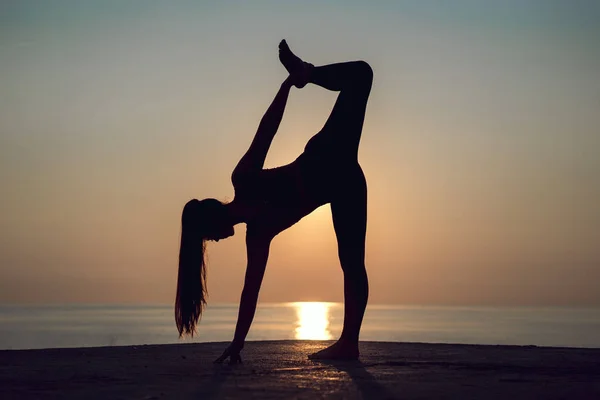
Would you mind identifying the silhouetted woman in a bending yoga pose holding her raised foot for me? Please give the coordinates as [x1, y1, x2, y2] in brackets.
[175, 40, 373, 362]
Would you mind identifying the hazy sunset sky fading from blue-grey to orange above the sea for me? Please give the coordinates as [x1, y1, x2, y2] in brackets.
[0, 0, 600, 306]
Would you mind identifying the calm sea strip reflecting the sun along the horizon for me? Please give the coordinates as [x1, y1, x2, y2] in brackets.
[0, 302, 600, 349]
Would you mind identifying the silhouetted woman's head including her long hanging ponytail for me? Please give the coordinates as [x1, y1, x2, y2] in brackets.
[175, 199, 233, 336]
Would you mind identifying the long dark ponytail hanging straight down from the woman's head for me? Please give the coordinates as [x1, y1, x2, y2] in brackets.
[175, 200, 208, 337]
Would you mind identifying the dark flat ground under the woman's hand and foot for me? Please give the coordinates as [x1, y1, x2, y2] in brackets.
[0, 341, 600, 400]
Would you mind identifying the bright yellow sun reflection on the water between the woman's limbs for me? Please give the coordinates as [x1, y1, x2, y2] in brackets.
[293, 302, 333, 340]
